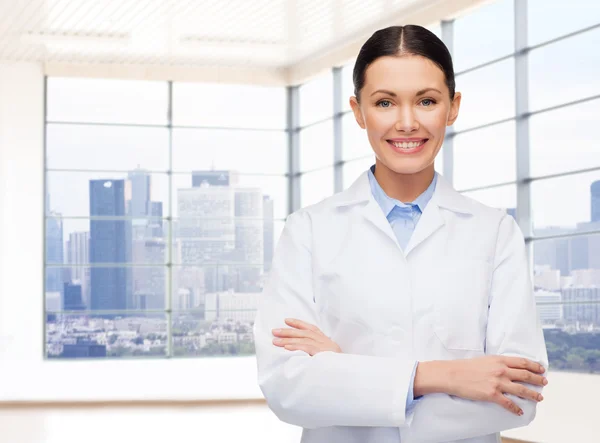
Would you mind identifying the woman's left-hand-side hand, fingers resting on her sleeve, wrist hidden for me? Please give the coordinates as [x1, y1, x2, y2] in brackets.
[273, 318, 342, 356]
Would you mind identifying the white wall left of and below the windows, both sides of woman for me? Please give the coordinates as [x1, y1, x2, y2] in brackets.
[0, 64, 600, 443]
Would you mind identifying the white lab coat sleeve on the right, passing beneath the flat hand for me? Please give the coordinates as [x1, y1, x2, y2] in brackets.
[401, 216, 548, 443]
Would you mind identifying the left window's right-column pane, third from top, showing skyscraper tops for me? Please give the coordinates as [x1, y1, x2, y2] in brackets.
[173, 171, 288, 219]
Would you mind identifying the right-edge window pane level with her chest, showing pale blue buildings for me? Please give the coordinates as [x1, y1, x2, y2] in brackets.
[533, 234, 600, 280]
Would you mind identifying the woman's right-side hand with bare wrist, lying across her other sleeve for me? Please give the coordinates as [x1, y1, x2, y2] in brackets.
[415, 355, 548, 415]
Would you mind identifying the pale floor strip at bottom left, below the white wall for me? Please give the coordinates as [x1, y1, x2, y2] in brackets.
[0, 404, 300, 443]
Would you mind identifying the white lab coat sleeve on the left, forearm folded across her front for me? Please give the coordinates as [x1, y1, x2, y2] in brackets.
[254, 211, 416, 428]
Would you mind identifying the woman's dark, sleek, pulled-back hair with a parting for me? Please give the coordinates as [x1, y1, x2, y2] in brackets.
[352, 25, 456, 100]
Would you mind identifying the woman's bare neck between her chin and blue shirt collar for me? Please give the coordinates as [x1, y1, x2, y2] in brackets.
[375, 160, 435, 203]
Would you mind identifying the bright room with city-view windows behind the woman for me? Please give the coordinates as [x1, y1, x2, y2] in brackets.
[0, 0, 600, 443]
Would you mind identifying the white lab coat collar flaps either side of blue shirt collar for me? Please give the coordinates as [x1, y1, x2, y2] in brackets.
[334, 171, 474, 214]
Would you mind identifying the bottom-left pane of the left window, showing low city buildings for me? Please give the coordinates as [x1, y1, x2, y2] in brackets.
[46, 312, 167, 359]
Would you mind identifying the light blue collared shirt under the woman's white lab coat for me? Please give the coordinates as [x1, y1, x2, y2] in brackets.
[369, 165, 437, 412]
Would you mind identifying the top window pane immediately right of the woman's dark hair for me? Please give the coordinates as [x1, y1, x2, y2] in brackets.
[453, 0, 515, 71]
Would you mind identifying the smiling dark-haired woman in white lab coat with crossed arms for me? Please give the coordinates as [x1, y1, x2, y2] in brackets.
[254, 25, 548, 443]
